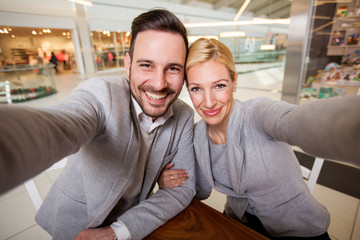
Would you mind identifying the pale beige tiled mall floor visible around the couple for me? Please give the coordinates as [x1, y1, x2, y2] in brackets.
[0, 65, 360, 240]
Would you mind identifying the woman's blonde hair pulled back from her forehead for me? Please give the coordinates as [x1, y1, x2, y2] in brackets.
[185, 38, 236, 83]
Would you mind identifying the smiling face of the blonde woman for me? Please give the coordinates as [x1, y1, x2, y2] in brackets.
[187, 60, 237, 126]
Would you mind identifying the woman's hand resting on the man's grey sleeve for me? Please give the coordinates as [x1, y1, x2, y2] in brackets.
[158, 163, 189, 188]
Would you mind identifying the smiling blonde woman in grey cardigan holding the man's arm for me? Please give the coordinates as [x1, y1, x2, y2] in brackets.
[159, 39, 360, 239]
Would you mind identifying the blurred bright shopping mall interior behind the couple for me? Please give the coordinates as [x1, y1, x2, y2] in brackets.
[0, 0, 360, 240]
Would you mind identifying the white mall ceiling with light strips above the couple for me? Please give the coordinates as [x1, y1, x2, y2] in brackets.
[0, 0, 291, 36]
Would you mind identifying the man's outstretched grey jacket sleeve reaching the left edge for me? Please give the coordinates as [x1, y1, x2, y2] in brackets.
[0, 78, 105, 193]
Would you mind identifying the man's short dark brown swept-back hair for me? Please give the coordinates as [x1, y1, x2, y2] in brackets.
[129, 9, 188, 59]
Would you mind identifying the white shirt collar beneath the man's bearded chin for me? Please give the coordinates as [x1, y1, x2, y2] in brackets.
[131, 95, 173, 134]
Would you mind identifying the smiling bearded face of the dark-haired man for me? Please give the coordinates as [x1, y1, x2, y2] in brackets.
[125, 30, 186, 120]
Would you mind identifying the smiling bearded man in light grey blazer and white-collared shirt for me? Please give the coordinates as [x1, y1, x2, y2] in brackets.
[0, 10, 195, 239]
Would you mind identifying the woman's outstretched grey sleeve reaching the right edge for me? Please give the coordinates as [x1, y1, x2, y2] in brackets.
[260, 96, 360, 166]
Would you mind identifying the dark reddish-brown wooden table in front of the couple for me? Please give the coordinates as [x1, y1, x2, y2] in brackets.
[145, 198, 268, 240]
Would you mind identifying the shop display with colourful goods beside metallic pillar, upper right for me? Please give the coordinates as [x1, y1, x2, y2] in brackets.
[283, 0, 360, 104]
